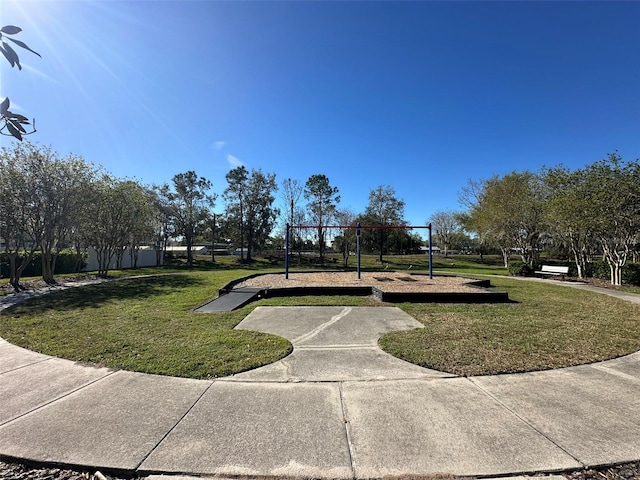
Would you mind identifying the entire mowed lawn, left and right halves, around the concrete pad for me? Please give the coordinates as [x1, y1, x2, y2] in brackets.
[0, 269, 640, 378]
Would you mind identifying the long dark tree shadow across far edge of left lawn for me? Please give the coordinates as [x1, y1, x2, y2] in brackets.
[7, 275, 204, 314]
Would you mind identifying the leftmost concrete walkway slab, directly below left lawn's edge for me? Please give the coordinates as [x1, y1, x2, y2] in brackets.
[0, 357, 113, 424]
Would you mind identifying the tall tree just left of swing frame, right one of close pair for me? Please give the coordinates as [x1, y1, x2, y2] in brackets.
[245, 170, 280, 261]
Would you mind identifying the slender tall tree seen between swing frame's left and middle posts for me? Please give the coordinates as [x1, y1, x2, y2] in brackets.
[304, 174, 340, 261]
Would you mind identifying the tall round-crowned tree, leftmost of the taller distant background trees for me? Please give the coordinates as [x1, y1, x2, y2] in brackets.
[169, 170, 215, 266]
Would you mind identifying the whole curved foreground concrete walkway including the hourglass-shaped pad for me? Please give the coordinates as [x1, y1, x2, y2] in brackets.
[0, 280, 640, 478]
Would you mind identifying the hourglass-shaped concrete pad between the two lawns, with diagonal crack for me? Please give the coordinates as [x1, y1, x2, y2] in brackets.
[230, 307, 444, 382]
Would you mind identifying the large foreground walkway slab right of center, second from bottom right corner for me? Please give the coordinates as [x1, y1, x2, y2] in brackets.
[342, 378, 582, 478]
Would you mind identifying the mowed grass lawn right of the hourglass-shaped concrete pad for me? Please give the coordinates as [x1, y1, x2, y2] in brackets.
[380, 278, 640, 375]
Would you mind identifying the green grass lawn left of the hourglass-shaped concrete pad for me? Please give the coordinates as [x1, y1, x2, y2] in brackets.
[0, 270, 291, 378]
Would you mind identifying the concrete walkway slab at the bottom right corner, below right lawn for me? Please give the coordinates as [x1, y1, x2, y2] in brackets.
[473, 366, 640, 466]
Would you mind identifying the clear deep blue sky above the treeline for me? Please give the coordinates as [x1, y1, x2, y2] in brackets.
[0, 0, 640, 231]
